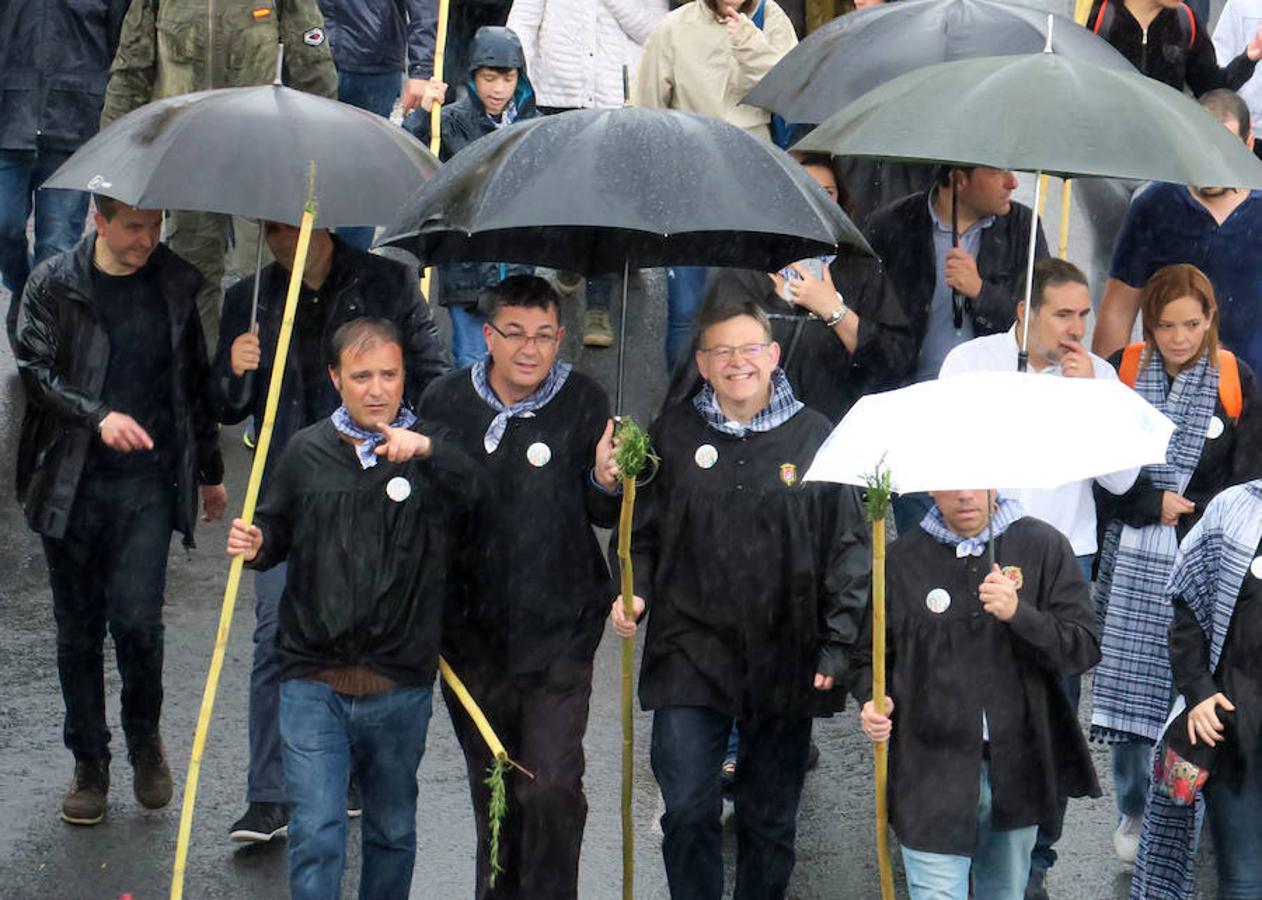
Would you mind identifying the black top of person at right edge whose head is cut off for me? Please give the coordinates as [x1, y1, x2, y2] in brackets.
[1170, 544, 1262, 786]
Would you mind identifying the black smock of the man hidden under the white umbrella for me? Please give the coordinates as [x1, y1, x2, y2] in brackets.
[851, 516, 1100, 856]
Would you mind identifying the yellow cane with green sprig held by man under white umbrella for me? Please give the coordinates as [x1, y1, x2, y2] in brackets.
[864, 463, 893, 900]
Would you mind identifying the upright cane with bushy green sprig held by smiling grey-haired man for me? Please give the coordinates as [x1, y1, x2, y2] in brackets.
[615, 416, 655, 900]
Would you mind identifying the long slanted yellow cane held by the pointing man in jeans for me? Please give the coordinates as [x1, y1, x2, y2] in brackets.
[170, 162, 317, 900]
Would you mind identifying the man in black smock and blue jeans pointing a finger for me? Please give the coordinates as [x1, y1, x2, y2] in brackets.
[228, 318, 477, 900]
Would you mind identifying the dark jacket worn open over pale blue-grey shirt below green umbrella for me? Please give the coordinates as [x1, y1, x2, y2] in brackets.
[867, 188, 1047, 383]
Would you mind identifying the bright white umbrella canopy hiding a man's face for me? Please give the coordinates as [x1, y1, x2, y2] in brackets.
[806, 372, 1175, 494]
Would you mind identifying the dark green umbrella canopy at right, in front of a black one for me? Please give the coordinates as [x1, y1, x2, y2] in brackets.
[794, 48, 1262, 188]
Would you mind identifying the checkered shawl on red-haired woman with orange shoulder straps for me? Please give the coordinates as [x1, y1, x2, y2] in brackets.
[1092, 352, 1218, 741]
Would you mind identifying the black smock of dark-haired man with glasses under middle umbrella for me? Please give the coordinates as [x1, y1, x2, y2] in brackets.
[420, 370, 622, 674]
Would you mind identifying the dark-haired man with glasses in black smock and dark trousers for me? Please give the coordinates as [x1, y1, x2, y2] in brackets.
[419, 275, 621, 900]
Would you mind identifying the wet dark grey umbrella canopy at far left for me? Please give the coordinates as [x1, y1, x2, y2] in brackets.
[43, 85, 438, 227]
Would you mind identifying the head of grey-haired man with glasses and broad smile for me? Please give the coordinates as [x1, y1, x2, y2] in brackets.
[697, 316, 780, 422]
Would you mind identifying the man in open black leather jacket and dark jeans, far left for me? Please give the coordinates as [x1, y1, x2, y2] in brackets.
[15, 197, 227, 826]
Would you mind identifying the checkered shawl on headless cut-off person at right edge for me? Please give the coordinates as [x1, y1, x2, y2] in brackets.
[1131, 481, 1262, 900]
